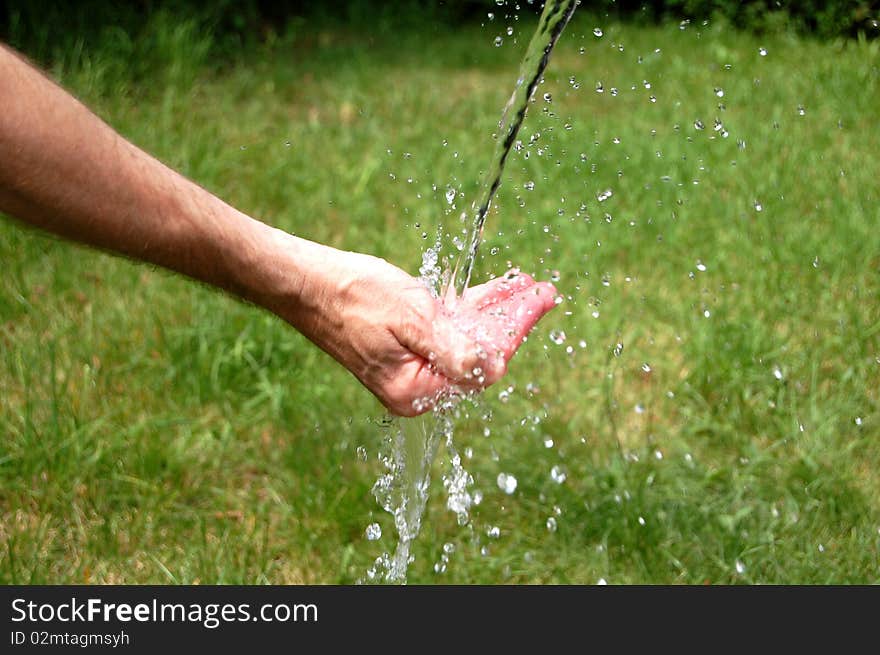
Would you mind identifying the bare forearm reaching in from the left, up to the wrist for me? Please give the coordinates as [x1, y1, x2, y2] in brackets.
[0, 46, 308, 316]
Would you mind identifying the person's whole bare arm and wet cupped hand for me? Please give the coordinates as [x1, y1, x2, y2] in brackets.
[0, 45, 556, 416]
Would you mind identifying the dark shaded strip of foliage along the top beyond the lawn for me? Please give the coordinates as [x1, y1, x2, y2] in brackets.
[0, 0, 880, 63]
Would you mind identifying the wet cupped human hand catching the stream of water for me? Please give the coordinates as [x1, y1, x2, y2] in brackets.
[287, 248, 556, 416]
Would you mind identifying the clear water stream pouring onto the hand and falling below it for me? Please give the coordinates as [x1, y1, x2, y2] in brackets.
[368, 0, 578, 583]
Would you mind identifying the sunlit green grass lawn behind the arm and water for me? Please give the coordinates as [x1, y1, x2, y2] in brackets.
[0, 11, 880, 584]
